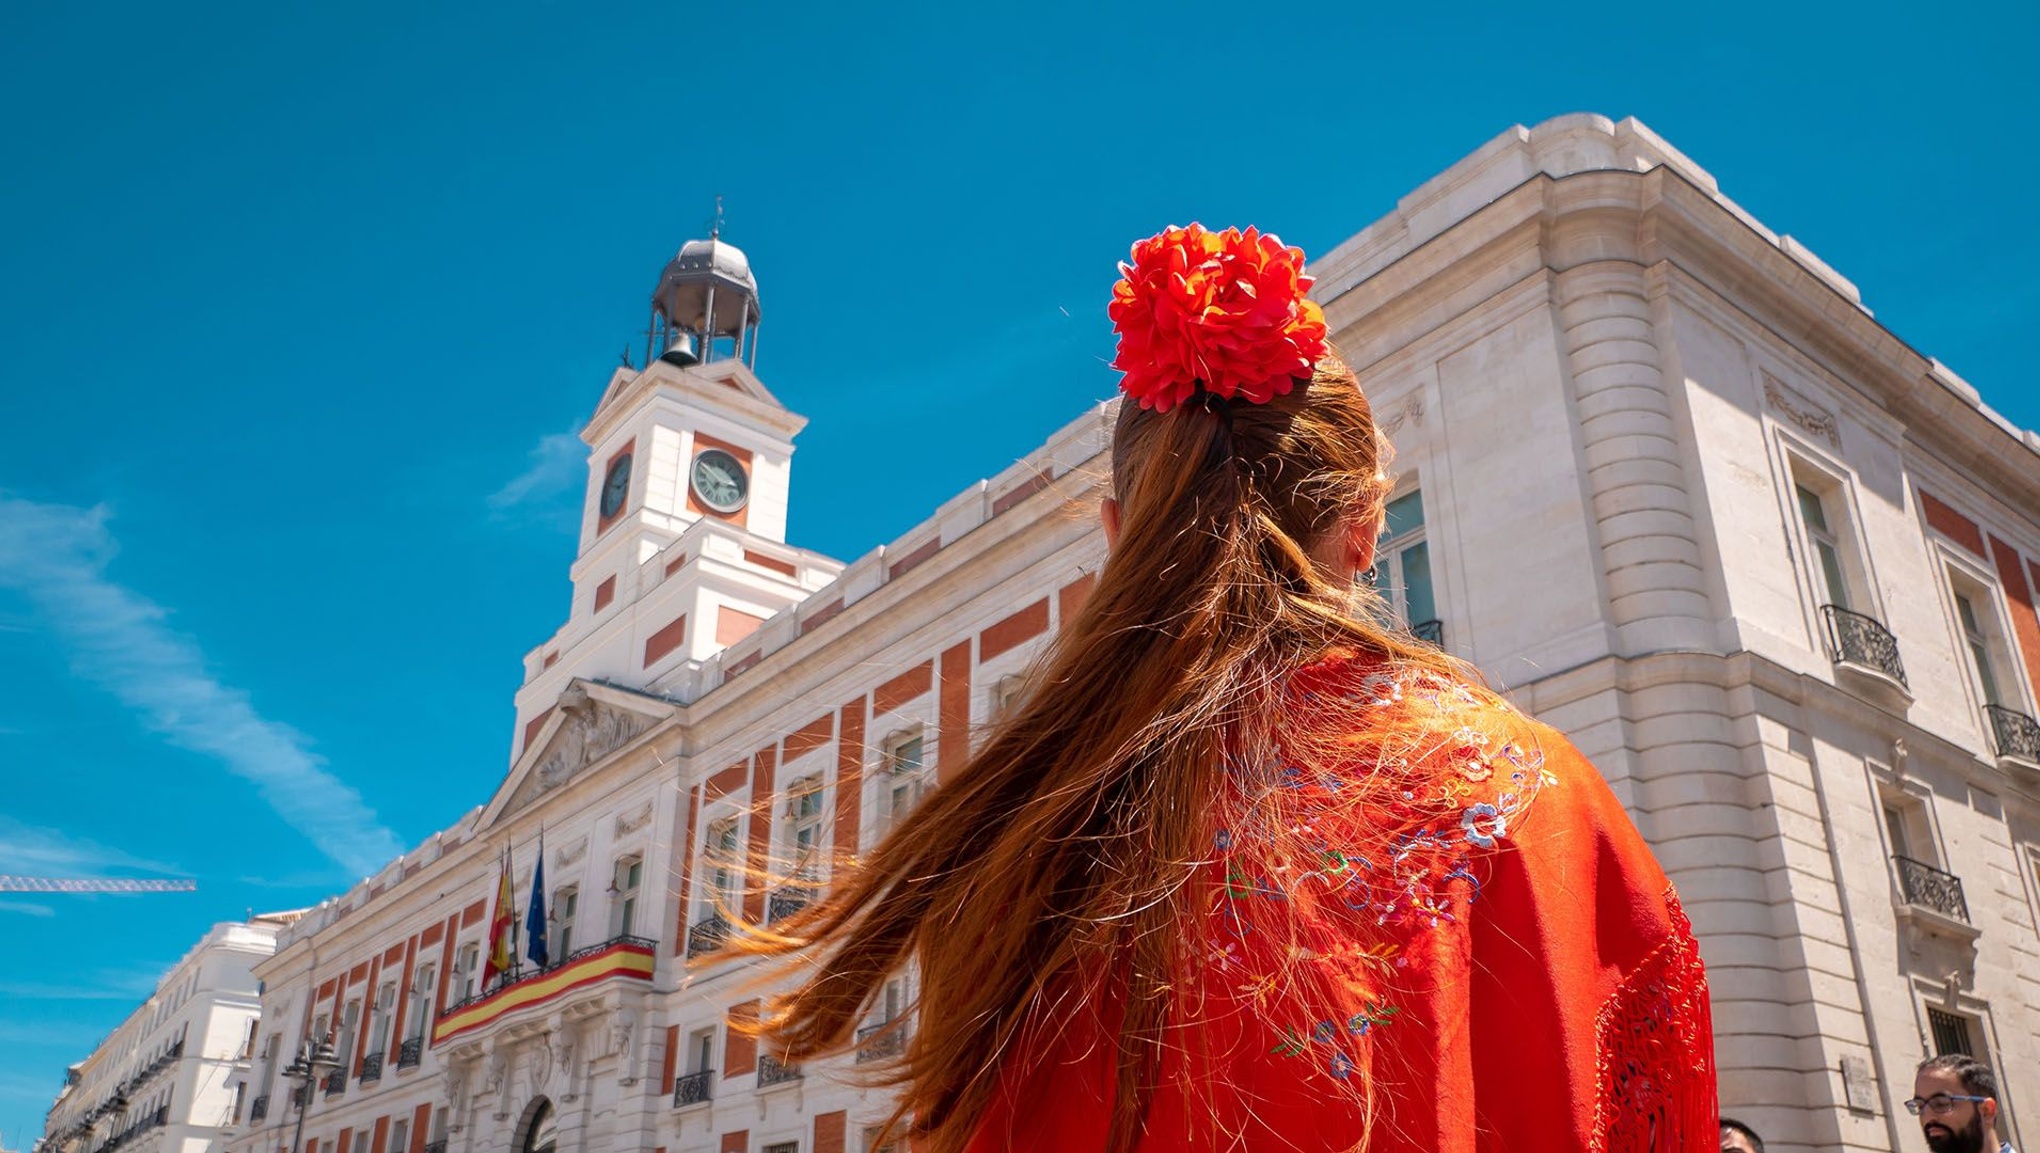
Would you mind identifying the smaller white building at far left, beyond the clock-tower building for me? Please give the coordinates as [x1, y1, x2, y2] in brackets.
[35, 912, 298, 1153]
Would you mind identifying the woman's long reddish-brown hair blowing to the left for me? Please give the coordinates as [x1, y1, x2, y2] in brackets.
[732, 357, 1465, 1153]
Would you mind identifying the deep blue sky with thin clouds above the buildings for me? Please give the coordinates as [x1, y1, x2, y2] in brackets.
[0, 2, 2040, 1145]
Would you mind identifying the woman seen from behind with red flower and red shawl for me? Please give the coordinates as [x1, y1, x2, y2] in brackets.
[734, 224, 1716, 1153]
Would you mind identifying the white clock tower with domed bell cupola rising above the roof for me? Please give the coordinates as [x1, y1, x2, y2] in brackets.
[512, 235, 843, 755]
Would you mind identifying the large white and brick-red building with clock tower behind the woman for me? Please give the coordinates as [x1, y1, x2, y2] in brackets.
[231, 116, 2040, 1153]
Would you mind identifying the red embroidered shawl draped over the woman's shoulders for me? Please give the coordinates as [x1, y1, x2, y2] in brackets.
[971, 661, 1718, 1153]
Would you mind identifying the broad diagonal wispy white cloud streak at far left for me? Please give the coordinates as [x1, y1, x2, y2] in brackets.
[0, 496, 402, 875]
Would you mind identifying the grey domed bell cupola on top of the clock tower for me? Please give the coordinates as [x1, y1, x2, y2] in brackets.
[647, 224, 759, 369]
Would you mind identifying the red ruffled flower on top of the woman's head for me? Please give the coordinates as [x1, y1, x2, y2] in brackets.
[1110, 224, 1326, 412]
